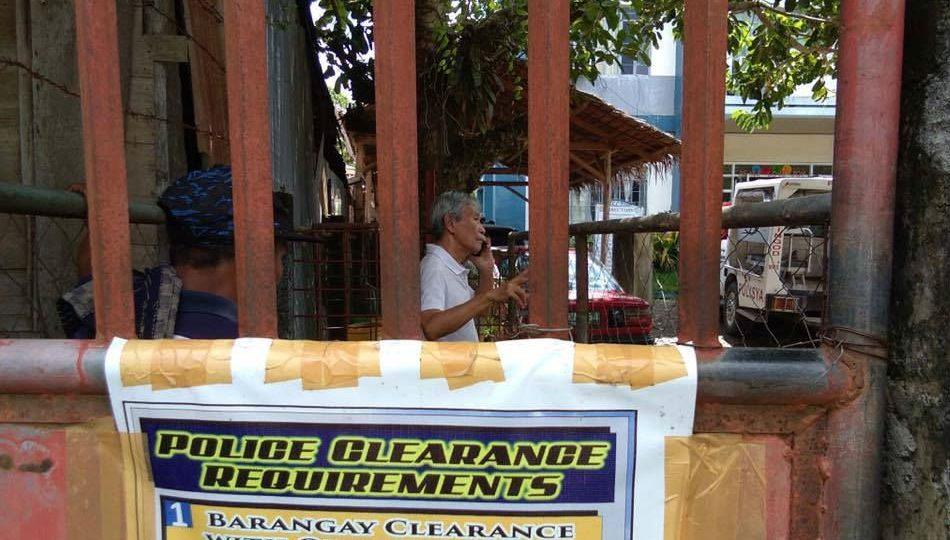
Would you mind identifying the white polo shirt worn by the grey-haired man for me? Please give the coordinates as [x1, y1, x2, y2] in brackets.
[419, 244, 478, 341]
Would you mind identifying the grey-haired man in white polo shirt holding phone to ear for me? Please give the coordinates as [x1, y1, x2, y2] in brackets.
[421, 191, 528, 341]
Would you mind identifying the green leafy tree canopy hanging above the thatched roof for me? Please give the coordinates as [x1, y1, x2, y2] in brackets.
[315, 0, 840, 187]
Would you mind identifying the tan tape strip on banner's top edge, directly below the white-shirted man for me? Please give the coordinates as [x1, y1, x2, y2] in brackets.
[419, 341, 505, 390]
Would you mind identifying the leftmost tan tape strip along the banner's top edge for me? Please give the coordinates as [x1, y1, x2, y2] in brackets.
[119, 339, 234, 390]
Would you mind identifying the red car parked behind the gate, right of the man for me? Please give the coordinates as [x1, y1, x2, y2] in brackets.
[568, 250, 653, 344]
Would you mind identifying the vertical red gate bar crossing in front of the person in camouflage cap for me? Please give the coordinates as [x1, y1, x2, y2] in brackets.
[224, 0, 277, 337]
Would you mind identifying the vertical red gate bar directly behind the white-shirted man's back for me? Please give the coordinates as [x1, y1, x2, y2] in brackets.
[373, 0, 422, 339]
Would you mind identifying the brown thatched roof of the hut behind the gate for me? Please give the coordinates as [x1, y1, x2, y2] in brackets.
[343, 89, 680, 187]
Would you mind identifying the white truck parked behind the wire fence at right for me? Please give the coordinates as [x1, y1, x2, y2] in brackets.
[719, 177, 831, 335]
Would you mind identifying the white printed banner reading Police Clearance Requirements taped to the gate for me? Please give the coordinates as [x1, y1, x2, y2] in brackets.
[106, 339, 696, 540]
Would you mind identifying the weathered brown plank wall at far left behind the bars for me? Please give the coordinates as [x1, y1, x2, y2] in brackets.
[0, 0, 184, 337]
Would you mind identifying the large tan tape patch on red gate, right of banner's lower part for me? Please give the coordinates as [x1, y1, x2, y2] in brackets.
[664, 434, 768, 540]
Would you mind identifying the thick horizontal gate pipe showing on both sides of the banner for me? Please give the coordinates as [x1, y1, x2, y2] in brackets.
[0, 339, 851, 405]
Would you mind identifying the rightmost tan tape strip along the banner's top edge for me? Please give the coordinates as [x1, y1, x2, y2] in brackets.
[573, 343, 686, 389]
